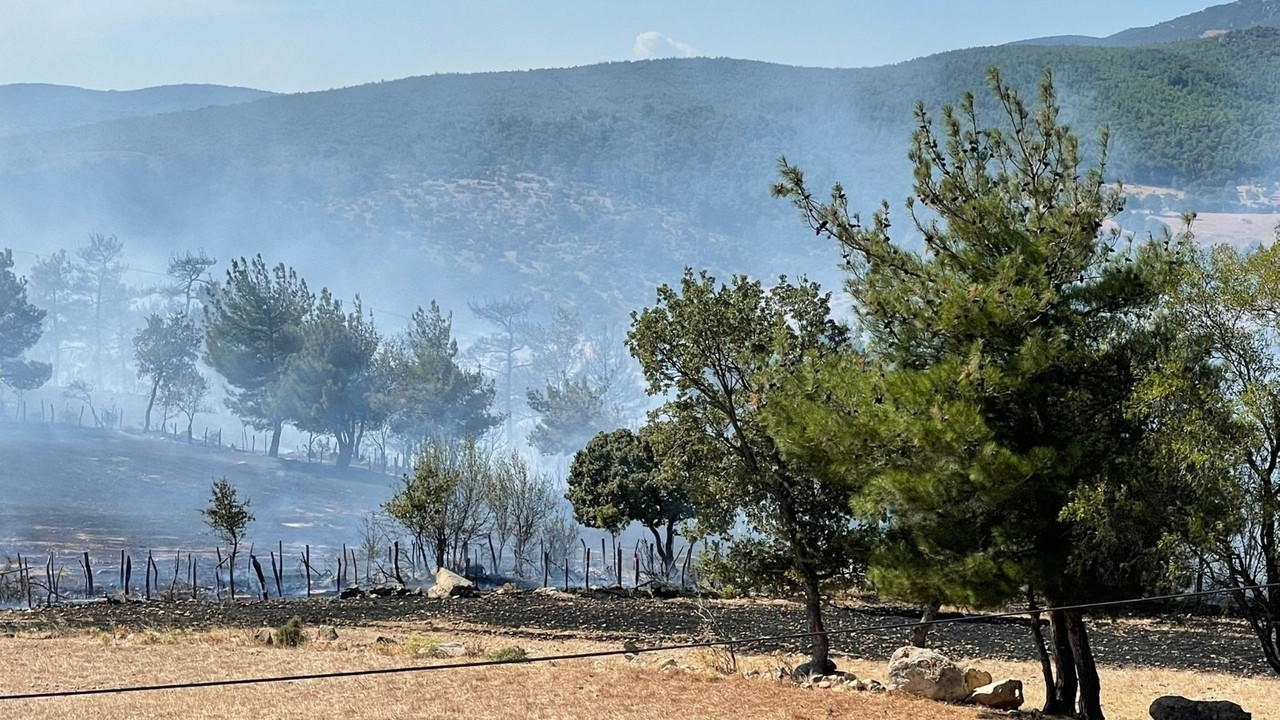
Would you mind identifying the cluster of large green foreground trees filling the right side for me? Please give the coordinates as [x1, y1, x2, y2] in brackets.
[570, 72, 1280, 720]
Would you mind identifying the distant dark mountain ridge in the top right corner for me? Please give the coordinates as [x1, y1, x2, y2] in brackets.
[1018, 0, 1280, 47]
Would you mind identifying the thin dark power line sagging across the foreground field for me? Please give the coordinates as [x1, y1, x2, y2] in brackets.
[0, 583, 1280, 702]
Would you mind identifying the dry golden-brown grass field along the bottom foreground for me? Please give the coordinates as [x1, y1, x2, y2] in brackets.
[0, 624, 1280, 720]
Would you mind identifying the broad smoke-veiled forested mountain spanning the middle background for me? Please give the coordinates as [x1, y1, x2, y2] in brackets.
[0, 28, 1280, 313]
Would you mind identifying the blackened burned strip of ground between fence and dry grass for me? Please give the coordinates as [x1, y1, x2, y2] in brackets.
[0, 591, 1268, 675]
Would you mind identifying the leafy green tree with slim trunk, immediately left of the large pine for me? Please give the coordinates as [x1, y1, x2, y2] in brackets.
[627, 270, 865, 671]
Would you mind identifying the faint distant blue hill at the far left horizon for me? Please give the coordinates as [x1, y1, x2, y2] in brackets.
[0, 83, 271, 136]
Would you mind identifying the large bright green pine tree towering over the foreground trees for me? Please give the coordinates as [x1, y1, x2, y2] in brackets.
[774, 72, 1213, 720]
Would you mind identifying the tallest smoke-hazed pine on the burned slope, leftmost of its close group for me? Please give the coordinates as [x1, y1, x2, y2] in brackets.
[205, 255, 312, 457]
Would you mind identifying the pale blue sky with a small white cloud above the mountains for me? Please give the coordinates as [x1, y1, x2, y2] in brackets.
[0, 0, 1213, 92]
